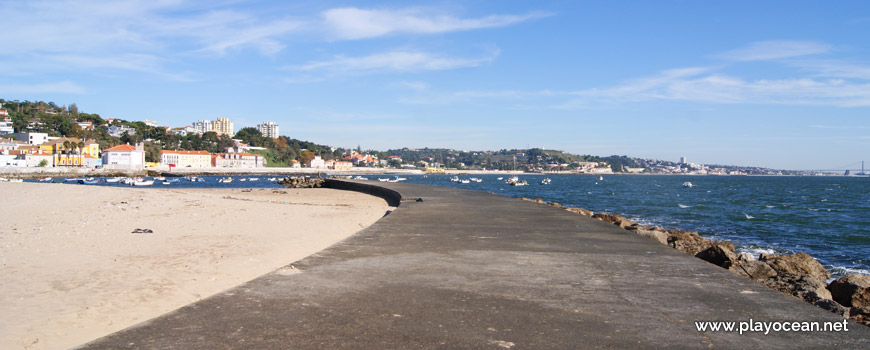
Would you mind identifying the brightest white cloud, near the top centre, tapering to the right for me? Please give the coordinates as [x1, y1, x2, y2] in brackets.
[322, 7, 552, 39]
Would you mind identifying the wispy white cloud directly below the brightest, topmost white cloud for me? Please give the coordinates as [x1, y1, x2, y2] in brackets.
[288, 50, 499, 72]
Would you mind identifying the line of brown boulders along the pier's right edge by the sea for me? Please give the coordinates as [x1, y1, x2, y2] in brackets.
[522, 198, 870, 326]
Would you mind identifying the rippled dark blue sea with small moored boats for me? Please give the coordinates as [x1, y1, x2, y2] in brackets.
[39, 174, 870, 278]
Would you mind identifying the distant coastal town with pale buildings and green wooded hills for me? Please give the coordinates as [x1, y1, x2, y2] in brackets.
[0, 99, 865, 176]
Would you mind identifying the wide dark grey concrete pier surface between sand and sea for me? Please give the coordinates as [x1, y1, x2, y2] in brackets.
[82, 180, 870, 349]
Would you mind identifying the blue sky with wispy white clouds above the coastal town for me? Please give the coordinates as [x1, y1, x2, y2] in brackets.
[0, 0, 870, 169]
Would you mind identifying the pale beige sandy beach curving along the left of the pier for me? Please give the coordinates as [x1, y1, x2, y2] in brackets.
[0, 183, 391, 349]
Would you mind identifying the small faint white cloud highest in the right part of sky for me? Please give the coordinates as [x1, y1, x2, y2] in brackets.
[715, 40, 831, 61]
